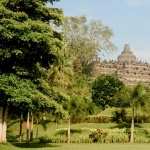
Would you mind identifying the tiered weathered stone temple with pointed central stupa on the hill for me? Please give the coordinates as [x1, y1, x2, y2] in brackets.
[93, 44, 150, 85]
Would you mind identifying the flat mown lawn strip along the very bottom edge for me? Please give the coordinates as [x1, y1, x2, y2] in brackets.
[0, 144, 150, 150]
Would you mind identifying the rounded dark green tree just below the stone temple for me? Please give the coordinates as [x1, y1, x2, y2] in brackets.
[92, 75, 124, 109]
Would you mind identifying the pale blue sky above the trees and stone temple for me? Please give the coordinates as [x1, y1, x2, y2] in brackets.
[55, 0, 150, 62]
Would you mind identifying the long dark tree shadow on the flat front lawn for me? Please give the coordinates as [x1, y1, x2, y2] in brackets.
[11, 143, 61, 148]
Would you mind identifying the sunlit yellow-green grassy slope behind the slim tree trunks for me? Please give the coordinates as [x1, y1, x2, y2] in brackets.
[8, 119, 150, 143]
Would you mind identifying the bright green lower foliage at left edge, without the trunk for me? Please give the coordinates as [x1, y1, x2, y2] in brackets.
[0, 74, 36, 107]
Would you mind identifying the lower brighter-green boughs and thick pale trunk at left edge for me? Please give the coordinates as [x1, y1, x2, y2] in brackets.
[0, 74, 36, 143]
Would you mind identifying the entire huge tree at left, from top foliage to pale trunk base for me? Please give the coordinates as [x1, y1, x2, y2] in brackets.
[0, 0, 63, 143]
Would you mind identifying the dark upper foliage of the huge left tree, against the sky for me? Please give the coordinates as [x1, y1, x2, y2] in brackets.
[0, 0, 63, 77]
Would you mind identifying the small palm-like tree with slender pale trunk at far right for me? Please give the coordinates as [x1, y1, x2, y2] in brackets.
[114, 84, 150, 143]
